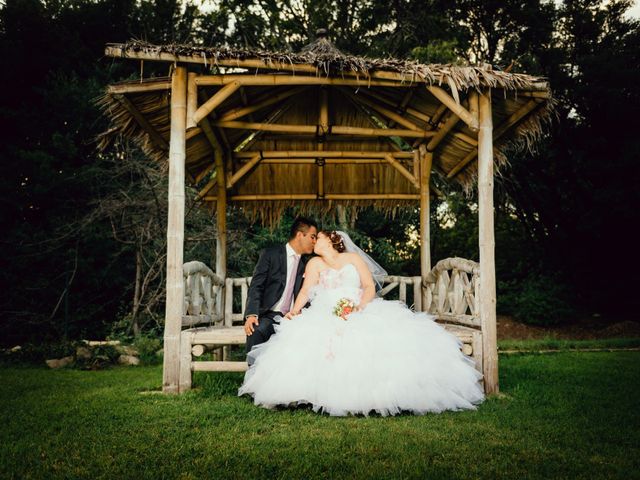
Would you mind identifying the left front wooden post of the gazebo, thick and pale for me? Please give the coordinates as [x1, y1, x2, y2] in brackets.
[162, 67, 187, 393]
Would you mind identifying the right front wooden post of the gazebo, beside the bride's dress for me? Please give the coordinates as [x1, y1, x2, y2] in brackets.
[477, 89, 498, 394]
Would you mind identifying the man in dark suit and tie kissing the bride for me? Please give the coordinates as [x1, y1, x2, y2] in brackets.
[244, 217, 318, 353]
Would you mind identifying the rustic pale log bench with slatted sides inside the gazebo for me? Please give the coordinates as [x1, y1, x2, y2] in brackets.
[180, 258, 483, 391]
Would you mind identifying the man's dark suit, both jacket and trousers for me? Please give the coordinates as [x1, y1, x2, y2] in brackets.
[244, 245, 310, 352]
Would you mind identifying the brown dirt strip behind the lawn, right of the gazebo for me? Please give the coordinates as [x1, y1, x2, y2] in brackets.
[497, 315, 640, 340]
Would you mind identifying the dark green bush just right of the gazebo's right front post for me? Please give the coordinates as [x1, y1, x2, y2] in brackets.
[498, 273, 575, 325]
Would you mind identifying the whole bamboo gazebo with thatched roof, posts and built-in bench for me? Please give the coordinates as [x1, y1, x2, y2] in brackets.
[100, 32, 554, 393]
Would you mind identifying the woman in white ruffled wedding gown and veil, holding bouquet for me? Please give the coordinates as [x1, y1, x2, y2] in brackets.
[238, 231, 484, 416]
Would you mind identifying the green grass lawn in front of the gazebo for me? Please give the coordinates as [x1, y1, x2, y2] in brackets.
[0, 344, 640, 480]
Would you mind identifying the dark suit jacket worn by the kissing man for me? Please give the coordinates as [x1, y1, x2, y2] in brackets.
[244, 245, 311, 318]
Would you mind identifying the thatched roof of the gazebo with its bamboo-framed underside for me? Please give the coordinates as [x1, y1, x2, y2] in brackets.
[99, 37, 554, 221]
